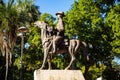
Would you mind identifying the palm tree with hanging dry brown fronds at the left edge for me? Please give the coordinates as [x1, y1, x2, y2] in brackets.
[0, 0, 40, 80]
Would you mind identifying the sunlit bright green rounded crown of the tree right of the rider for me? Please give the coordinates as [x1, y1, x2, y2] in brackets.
[64, 0, 102, 40]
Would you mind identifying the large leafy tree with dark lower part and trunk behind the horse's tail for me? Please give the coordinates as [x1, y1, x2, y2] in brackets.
[64, 0, 114, 79]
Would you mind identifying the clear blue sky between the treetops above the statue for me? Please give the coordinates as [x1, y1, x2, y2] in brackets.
[35, 0, 74, 16]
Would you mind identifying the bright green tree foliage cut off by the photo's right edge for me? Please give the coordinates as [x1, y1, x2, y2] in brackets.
[106, 4, 120, 57]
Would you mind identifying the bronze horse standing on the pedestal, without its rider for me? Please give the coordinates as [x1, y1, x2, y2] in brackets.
[34, 21, 88, 69]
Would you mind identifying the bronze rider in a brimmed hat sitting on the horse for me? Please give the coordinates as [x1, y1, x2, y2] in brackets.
[53, 12, 65, 53]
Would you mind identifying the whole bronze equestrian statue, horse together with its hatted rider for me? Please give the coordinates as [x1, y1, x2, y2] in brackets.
[34, 12, 89, 70]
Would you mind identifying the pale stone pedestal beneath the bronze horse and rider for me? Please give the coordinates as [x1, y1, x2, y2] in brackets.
[34, 70, 85, 80]
